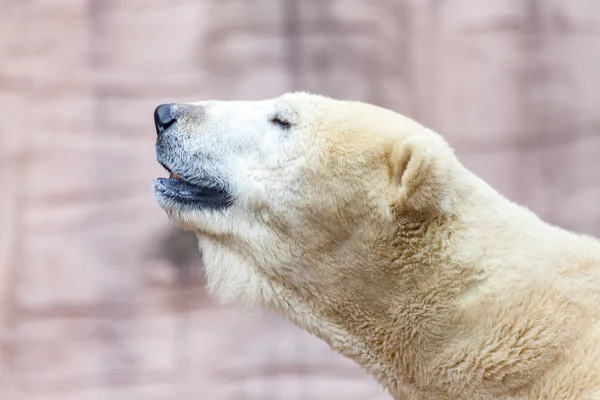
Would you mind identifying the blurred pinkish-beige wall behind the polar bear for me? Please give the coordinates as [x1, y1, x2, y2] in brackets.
[0, 0, 600, 400]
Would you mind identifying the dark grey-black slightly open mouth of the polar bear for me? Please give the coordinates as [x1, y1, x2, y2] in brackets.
[154, 163, 232, 209]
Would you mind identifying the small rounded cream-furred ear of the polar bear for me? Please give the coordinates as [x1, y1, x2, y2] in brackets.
[388, 134, 454, 214]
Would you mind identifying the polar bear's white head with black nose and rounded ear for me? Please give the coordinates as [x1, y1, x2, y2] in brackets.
[155, 93, 454, 314]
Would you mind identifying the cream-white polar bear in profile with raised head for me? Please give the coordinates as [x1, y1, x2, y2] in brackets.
[154, 93, 600, 400]
